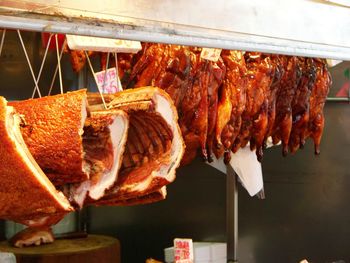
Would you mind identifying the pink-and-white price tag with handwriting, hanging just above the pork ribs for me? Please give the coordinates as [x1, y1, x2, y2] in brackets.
[95, 68, 123, 93]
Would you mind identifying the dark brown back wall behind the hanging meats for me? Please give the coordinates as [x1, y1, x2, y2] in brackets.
[0, 32, 350, 263]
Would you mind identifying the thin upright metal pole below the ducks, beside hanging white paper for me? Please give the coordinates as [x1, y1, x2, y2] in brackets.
[226, 165, 238, 263]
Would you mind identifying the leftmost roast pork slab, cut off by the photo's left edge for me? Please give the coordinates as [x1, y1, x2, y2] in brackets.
[0, 97, 72, 226]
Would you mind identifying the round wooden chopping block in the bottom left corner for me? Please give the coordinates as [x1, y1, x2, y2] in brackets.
[0, 235, 120, 263]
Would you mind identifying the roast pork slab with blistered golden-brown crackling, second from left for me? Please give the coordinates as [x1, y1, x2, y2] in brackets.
[10, 90, 90, 185]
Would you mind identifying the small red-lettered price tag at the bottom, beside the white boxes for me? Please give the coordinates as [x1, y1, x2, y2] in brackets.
[174, 238, 193, 263]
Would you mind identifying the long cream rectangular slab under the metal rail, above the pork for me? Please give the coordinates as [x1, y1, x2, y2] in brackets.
[67, 35, 142, 53]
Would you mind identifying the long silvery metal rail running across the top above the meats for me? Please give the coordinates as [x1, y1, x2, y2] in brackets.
[0, 13, 350, 60]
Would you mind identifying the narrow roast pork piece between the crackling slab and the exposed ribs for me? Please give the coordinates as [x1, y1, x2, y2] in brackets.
[65, 110, 129, 207]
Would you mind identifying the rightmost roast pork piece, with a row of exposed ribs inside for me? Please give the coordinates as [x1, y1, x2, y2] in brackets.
[89, 87, 184, 205]
